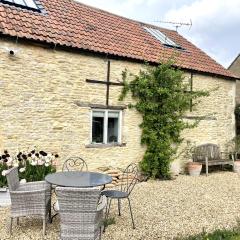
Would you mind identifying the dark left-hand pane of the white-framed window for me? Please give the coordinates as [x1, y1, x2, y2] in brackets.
[92, 114, 104, 143]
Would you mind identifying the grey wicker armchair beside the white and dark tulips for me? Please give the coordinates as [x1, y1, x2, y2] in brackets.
[6, 167, 51, 235]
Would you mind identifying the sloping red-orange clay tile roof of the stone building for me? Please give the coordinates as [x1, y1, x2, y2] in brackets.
[0, 0, 235, 78]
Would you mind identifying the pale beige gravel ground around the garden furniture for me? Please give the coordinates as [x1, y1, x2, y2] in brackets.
[0, 172, 240, 240]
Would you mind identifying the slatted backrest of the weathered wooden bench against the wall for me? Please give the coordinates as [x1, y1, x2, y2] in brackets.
[192, 143, 221, 162]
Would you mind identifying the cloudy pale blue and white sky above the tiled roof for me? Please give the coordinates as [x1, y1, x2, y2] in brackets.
[78, 0, 240, 68]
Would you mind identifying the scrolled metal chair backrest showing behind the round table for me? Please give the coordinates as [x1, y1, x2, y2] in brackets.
[62, 157, 88, 172]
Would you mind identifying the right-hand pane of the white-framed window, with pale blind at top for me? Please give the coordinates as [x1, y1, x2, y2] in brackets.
[108, 112, 119, 143]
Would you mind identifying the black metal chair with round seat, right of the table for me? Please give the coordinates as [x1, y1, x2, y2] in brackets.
[101, 164, 139, 231]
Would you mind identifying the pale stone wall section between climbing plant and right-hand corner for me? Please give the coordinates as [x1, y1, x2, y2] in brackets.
[178, 74, 236, 169]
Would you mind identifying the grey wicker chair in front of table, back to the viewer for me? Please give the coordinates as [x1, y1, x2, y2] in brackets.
[56, 187, 107, 240]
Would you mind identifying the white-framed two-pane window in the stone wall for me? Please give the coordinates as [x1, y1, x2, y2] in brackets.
[91, 109, 122, 144]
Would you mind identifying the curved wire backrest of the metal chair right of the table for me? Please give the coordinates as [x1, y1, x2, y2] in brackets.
[119, 163, 139, 194]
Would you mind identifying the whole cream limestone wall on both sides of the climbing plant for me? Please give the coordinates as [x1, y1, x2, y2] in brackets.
[0, 39, 235, 170]
